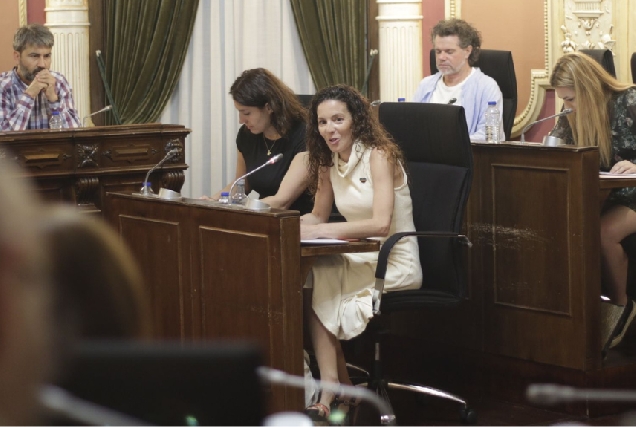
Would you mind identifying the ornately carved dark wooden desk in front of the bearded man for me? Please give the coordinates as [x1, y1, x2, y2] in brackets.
[0, 123, 190, 211]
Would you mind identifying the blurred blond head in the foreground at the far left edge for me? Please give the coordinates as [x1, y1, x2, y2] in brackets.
[0, 161, 54, 425]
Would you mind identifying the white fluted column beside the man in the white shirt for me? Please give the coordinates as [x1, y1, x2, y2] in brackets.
[376, 0, 422, 102]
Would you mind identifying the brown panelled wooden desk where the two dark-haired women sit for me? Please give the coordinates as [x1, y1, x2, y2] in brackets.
[104, 193, 379, 412]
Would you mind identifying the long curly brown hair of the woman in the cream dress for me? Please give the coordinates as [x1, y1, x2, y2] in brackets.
[306, 84, 404, 194]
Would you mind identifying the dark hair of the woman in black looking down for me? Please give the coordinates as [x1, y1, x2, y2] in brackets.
[230, 68, 307, 136]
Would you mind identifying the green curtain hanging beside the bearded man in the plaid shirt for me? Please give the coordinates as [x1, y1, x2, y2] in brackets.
[104, 0, 199, 124]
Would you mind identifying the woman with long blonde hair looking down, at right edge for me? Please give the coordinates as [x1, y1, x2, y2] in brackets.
[550, 52, 636, 347]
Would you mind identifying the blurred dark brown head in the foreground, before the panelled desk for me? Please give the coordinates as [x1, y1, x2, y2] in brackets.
[41, 206, 150, 351]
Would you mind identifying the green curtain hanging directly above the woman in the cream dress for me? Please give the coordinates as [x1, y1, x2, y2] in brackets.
[290, 0, 367, 93]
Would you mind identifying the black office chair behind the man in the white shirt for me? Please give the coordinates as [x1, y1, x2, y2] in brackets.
[430, 49, 517, 141]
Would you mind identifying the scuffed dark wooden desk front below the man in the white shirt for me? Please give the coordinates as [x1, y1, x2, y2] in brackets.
[476, 144, 601, 370]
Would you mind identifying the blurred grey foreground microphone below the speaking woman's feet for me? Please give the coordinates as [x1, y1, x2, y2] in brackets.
[257, 366, 395, 425]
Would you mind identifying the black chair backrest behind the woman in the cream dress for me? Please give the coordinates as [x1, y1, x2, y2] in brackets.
[378, 102, 473, 296]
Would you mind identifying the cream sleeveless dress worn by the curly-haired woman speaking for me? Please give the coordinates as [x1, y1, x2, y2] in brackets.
[308, 142, 422, 340]
